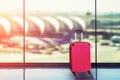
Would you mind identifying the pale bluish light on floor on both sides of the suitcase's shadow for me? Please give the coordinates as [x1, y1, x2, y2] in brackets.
[0, 68, 120, 80]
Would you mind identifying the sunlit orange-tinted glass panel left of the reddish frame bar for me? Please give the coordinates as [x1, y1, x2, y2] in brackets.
[0, 0, 23, 63]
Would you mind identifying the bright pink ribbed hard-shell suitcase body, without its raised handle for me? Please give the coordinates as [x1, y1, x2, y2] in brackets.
[70, 32, 91, 73]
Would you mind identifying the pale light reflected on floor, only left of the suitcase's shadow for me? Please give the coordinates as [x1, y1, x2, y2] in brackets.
[0, 68, 74, 80]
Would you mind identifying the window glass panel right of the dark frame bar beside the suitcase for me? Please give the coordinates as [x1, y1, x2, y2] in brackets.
[96, 0, 120, 63]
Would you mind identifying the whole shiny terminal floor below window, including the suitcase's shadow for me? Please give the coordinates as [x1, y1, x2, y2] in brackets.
[0, 64, 120, 80]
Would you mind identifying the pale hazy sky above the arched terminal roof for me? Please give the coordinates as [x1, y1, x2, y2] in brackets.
[0, 0, 120, 13]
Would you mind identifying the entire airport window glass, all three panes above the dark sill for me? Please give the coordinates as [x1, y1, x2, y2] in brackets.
[0, 0, 120, 63]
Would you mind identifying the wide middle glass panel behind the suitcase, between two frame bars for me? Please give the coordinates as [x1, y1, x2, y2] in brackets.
[25, 0, 94, 63]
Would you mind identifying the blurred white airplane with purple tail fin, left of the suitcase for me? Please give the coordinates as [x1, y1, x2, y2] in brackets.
[0, 29, 75, 51]
